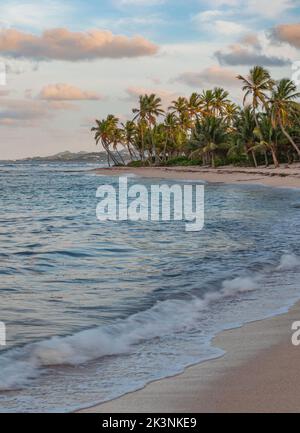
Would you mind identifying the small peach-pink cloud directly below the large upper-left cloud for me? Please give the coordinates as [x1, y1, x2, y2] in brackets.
[39, 83, 103, 101]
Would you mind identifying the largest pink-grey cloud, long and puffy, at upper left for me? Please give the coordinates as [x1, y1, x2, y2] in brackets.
[0, 28, 158, 61]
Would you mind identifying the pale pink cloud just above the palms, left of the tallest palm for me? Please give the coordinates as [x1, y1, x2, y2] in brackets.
[175, 66, 238, 88]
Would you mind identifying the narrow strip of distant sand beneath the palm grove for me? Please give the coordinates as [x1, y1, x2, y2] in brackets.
[92, 163, 300, 188]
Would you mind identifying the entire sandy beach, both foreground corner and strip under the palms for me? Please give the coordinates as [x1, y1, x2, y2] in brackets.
[77, 164, 300, 413]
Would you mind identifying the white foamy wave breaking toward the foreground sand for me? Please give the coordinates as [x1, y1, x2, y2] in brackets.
[0, 255, 299, 391]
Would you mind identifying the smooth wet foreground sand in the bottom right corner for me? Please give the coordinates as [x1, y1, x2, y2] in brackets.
[77, 301, 300, 413]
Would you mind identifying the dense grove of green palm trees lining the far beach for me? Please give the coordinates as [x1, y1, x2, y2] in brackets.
[92, 66, 300, 167]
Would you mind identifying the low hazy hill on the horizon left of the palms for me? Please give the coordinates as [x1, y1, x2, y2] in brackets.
[2, 150, 127, 163]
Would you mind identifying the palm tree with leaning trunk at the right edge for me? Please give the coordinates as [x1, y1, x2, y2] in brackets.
[270, 78, 300, 156]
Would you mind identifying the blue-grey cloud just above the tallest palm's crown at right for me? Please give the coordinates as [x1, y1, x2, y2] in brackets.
[215, 44, 290, 66]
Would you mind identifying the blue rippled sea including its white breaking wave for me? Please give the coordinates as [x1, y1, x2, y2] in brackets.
[0, 160, 300, 411]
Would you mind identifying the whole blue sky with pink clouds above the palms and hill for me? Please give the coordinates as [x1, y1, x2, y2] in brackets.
[0, 0, 300, 160]
